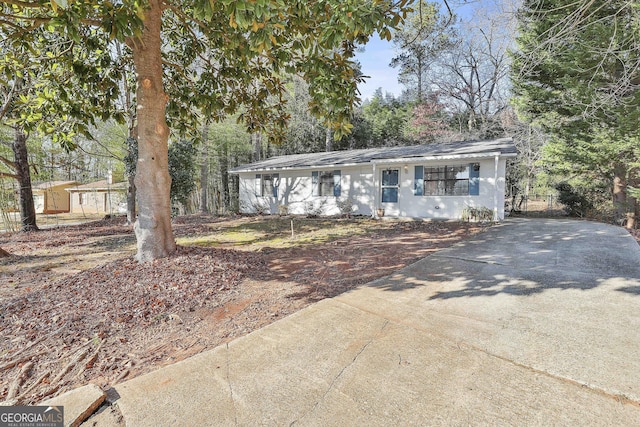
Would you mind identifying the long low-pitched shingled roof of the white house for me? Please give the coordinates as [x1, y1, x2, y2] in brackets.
[229, 138, 517, 173]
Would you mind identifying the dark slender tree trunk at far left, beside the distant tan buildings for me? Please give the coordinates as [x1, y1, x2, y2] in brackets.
[12, 127, 38, 231]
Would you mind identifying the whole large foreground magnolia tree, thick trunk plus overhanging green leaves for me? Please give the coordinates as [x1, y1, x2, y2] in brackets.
[0, 0, 408, 261]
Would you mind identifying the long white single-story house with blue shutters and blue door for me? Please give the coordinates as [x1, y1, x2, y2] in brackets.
[230, 138, 517, 220]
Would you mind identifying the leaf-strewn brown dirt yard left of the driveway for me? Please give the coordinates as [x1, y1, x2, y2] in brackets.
[0, 215, 524, 404]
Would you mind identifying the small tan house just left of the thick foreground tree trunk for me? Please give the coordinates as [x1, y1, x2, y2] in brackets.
[67, 179, 127, 214]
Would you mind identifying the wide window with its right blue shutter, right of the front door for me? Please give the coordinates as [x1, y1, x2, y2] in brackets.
[423, 163, 480, 196]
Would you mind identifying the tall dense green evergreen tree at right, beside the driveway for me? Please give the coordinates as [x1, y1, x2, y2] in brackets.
[512, 0, 640, 227]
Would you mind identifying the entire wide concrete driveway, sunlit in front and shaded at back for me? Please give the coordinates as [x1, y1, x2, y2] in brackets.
[87, 219, 640, 427]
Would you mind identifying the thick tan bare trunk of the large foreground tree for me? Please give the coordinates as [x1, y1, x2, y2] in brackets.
[129, 0, 176, 262]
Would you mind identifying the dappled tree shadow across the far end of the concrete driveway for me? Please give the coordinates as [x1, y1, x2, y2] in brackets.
[369, 219, 640, 300]
